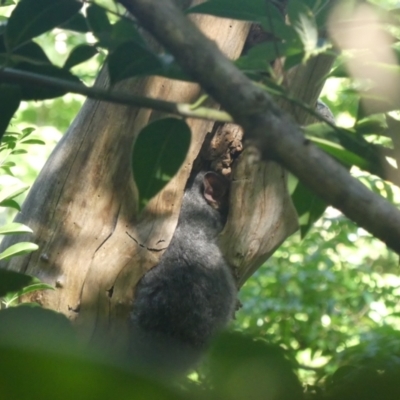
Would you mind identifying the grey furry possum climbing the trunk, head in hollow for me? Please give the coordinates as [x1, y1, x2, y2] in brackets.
[131, 172, 237, 373]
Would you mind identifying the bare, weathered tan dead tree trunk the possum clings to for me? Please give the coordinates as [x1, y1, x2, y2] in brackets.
[0, 3, 332, 349]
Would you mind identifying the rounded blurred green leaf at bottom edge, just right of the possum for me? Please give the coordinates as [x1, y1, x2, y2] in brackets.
[209, 332, 303, 400]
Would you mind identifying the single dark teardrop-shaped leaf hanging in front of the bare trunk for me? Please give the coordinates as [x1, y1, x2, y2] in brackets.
[132, 118, 191, 210]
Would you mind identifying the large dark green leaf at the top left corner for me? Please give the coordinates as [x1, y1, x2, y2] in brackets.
[5, 0, 82, 50]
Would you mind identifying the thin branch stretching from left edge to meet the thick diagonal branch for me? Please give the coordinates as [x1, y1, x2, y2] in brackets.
[0, 68, 232, 122]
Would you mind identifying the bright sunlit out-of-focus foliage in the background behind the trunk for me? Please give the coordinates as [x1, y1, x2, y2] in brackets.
[0, 0, 400, 397]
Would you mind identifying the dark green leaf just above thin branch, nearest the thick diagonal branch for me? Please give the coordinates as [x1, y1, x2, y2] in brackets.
[108, 42, 162, 84]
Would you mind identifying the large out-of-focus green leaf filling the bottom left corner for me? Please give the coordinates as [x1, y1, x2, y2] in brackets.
[0, 307, 184, 400]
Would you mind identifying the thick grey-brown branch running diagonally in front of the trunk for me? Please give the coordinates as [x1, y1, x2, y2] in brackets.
[117, 0, 400, 253]
